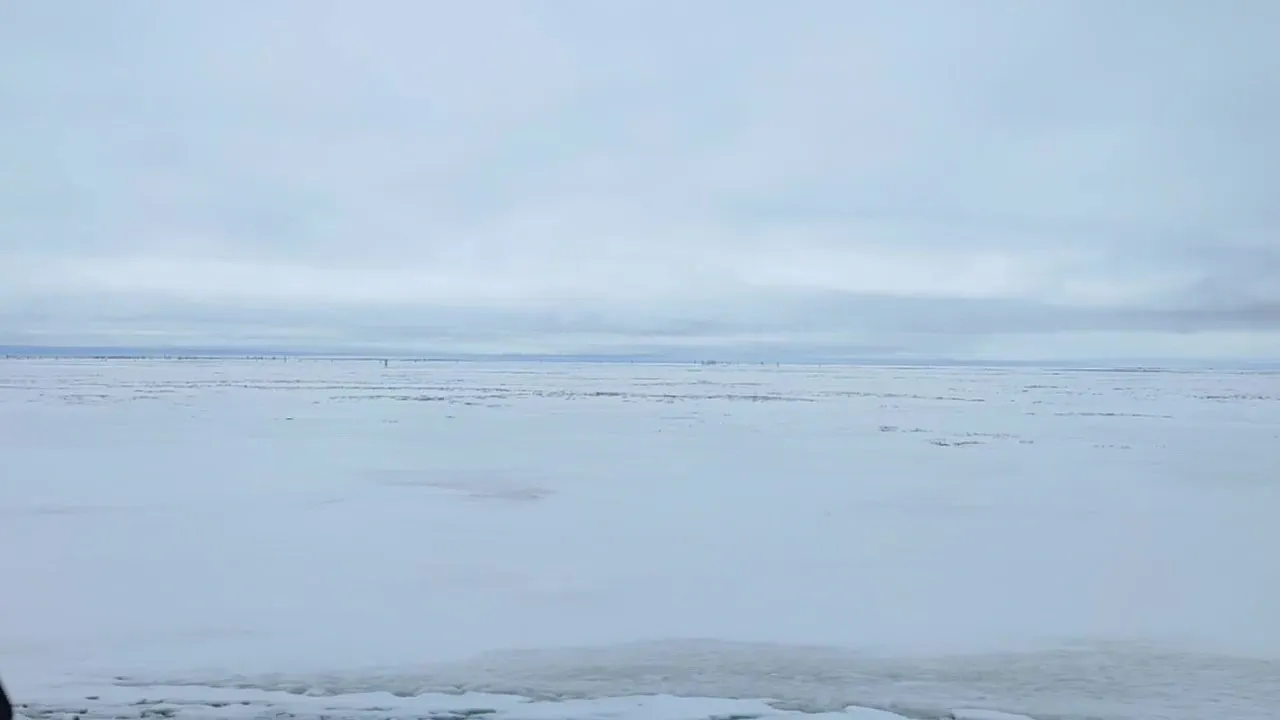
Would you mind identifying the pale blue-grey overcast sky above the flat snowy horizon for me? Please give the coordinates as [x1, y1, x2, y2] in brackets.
[0, 0, 1280, 357]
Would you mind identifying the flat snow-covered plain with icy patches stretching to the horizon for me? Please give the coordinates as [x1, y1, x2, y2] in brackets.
[0, 360, 1280, 720]
